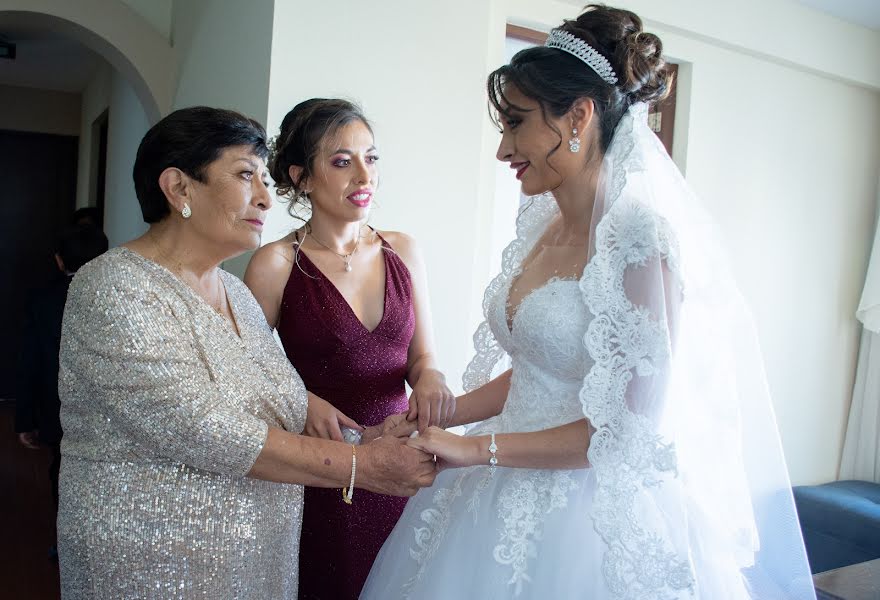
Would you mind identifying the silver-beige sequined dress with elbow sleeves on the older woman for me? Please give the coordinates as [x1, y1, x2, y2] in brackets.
[58, 248, 307, 600]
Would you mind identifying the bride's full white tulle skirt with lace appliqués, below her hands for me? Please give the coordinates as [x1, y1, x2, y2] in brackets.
[360, 467, 611, 600]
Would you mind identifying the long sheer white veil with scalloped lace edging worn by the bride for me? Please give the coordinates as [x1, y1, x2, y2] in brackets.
[464, 104, 815, 600]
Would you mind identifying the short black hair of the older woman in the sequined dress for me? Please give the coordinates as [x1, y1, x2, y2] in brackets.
[132, 106, 269, 223]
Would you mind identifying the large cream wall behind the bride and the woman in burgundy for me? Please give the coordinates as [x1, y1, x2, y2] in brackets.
[266, 0, 880, 483]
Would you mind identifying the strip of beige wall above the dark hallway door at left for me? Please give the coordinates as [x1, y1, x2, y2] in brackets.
[0, 85, 80, 135]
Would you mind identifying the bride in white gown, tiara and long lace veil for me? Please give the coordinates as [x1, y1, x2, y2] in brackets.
[361, 6, 815, 600]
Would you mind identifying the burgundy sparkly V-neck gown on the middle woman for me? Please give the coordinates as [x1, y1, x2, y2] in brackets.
[278, 234, 415, 600]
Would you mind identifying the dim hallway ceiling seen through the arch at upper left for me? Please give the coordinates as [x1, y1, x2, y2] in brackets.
[0, 25, 104, 92]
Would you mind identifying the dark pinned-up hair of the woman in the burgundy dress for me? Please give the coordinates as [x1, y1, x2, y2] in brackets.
[269, 98, 373, 218]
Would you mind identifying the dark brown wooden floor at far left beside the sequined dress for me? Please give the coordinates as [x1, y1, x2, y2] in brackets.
[0, 401, 61, 600]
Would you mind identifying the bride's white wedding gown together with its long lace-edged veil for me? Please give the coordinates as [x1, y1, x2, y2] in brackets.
[361, 104, 815, 600]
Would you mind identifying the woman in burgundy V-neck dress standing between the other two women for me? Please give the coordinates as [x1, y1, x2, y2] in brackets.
[245, 99, 455, 600]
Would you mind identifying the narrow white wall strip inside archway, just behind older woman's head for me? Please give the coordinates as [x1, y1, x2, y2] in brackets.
[104, 72, 150, 247]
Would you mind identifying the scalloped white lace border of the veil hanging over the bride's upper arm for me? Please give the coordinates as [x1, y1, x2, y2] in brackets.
[580, 200, 693, 599]
